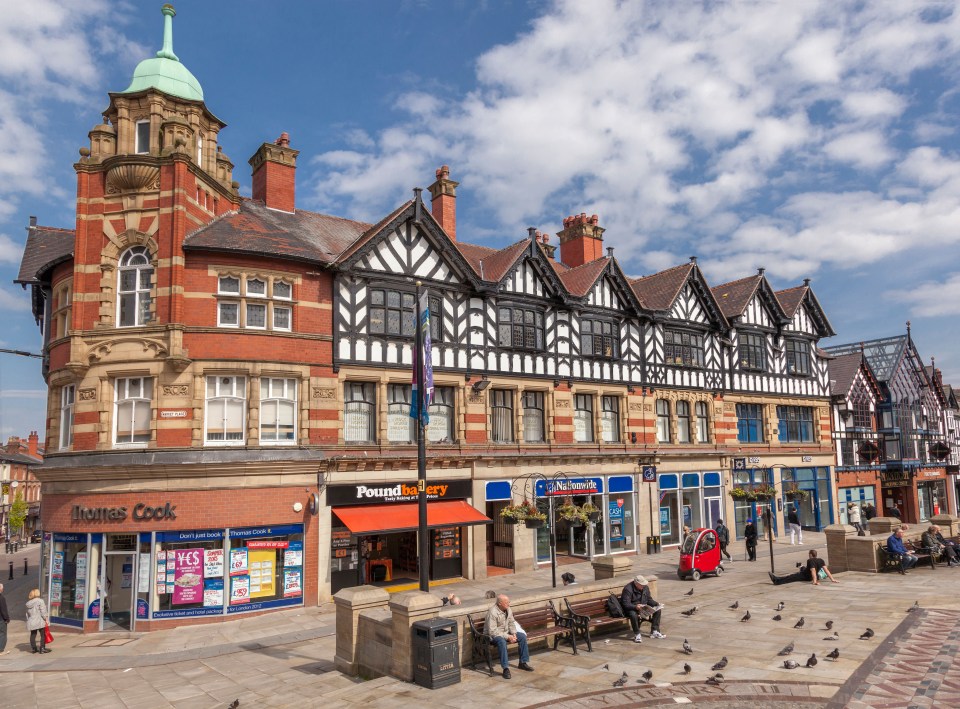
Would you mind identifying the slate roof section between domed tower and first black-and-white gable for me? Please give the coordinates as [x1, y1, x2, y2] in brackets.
[184, 199, 372, 263]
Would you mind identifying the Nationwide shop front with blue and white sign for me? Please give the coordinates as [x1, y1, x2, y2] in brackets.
[534, 475, 638, 563]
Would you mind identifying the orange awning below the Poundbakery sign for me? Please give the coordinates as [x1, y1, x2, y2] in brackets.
[333, 500, 493, 534]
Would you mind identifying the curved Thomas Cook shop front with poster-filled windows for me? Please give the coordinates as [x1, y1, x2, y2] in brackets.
[41, 488, 317, 632]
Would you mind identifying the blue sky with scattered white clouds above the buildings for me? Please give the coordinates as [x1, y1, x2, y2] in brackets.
[0, 0, 960, 439]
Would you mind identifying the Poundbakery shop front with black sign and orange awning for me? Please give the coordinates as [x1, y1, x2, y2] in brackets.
[327, 480, 491, 593]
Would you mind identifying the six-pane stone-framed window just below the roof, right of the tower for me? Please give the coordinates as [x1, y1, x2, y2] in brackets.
[217, 275, 293, 332]
